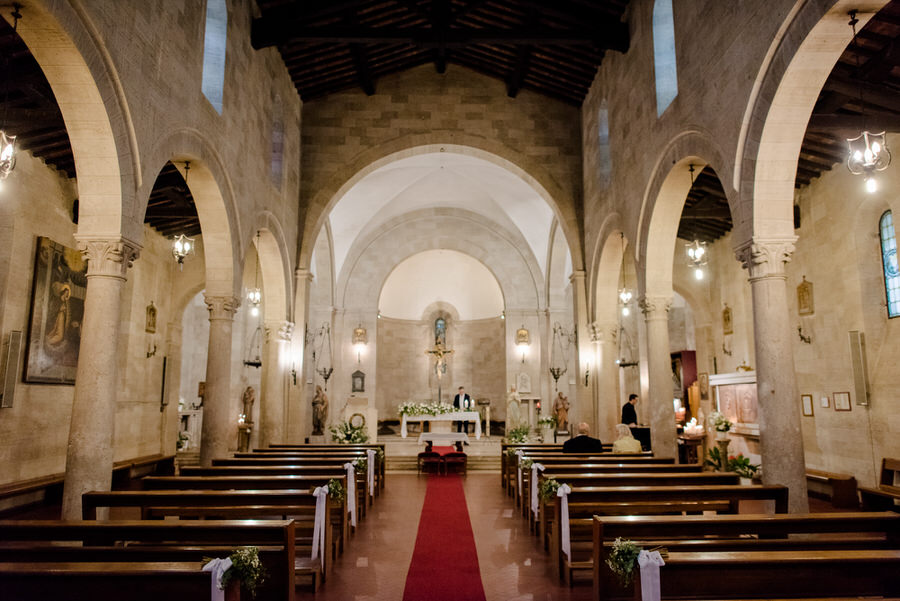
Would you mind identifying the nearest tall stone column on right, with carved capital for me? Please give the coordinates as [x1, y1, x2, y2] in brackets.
[736, 238, 809, 513]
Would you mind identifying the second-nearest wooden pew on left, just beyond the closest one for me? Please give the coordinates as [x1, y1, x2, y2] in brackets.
[0, 520, 298, 601]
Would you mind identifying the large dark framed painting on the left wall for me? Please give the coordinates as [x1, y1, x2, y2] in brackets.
[24, 236, 87, 384]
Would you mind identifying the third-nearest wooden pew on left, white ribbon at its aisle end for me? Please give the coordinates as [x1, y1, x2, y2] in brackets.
[81, 490, 335, 581]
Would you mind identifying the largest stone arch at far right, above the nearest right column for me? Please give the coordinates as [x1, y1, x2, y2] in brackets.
[736, 0, 888, 245]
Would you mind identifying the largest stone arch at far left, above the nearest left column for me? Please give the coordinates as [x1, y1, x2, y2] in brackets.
[11, 0, 143, 242]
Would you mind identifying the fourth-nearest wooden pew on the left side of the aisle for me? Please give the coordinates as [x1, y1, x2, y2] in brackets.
[141, 472, 351, 553]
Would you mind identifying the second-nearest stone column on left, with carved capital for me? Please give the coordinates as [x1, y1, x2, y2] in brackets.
[200, 294, 240, 467]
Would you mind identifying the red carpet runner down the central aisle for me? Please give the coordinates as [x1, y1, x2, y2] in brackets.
[403, 474, 485, 601]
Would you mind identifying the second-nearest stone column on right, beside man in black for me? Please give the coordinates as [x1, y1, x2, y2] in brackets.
[637, 296, 678, 457]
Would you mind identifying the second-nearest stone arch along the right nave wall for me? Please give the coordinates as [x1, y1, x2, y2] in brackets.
[635, 130, 741, 296]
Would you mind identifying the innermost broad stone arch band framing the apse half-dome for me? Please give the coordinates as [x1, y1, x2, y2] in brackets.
[335, 209, 543, 309]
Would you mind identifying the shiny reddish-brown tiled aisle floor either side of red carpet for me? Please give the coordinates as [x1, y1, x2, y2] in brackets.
[315, 472, 591, 601]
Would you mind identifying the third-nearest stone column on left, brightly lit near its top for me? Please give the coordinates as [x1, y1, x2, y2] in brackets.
[259, 320, 294, 447]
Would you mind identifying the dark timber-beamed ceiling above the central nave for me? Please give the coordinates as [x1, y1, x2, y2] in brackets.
[252, 0, 629, 106]
